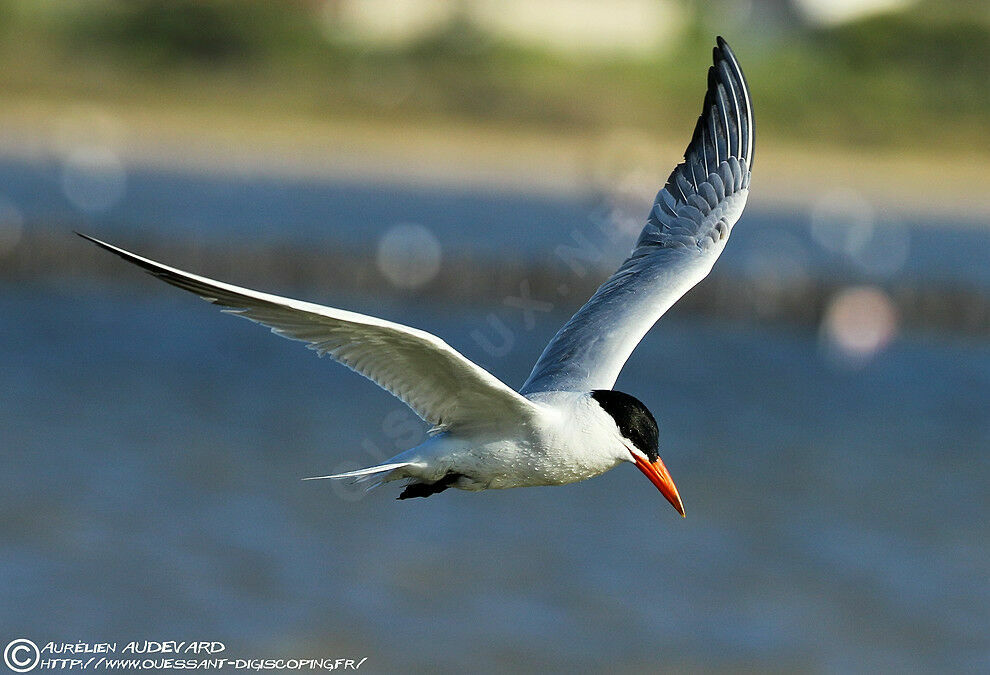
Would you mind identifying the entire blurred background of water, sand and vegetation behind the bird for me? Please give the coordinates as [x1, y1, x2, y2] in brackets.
[0, 0, 990, 672]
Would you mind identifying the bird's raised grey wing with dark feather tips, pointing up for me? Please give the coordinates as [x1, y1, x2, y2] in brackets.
[520, 38, 753, 394]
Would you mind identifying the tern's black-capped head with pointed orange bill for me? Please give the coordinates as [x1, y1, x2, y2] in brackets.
[591, 389, 684, 516]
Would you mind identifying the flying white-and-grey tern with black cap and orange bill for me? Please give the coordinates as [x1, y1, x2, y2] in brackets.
[80, 37, 753, 515]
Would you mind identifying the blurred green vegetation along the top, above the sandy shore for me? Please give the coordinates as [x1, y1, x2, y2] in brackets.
[0, 0, 990, 154]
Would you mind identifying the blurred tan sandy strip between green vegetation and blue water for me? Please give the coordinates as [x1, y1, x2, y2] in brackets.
[0, 96, 990, 229]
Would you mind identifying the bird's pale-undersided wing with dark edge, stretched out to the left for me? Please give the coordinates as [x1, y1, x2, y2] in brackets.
[77, 233, 535, 427]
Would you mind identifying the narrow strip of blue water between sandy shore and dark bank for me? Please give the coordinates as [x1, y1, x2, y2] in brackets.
[0, 157, 990, 289]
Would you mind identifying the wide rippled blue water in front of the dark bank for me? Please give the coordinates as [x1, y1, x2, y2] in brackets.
[0, 278, 990, 672]
